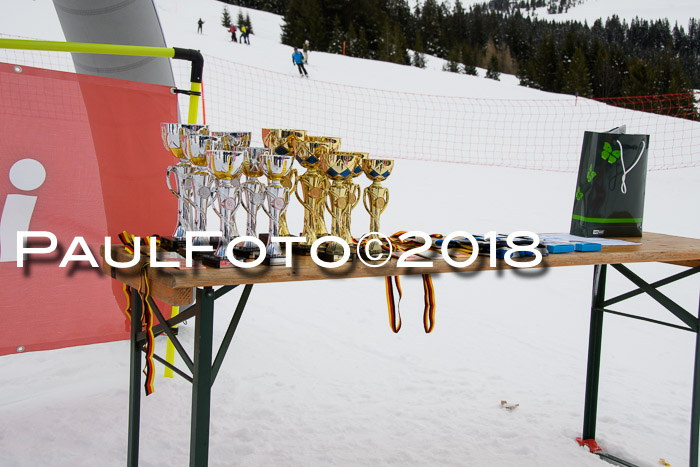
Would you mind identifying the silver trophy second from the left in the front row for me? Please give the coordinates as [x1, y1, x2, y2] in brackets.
[181, 133, 218, 249]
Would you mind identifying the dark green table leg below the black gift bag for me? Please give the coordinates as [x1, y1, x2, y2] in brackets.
[582, 264, 606, 440]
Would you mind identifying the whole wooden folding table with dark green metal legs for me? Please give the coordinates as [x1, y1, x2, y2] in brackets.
[101, 233, 700, 467]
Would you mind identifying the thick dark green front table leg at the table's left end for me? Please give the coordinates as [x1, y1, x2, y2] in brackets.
[190, 287, 214, 467]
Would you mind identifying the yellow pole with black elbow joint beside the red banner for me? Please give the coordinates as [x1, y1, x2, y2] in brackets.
[0, 38, 204, 378]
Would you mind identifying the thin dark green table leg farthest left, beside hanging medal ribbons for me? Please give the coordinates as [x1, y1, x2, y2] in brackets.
[127, 288, 143, 467]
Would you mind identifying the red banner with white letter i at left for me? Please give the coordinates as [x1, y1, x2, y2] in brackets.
[0, 63, 177, 355]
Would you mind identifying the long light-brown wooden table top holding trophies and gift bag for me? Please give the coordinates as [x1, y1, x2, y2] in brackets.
[101, 232, 700, 305]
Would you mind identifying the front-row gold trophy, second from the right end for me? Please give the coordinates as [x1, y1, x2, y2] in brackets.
[321, 152, 362, 261]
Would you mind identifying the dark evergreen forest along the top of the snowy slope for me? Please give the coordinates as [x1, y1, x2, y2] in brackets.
[219, 0, 700, 102]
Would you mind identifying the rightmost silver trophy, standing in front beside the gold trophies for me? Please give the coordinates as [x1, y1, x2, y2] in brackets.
[263, 154, 294, 266]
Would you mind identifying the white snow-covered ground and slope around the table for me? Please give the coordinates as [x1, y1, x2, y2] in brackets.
[0, 0, 700, 467]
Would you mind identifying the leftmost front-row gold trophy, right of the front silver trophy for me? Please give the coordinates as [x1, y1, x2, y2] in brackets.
[293, 136, 340, 255]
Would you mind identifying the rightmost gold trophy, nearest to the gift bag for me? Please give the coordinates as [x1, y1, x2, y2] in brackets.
[362, 159, 394, 259]
